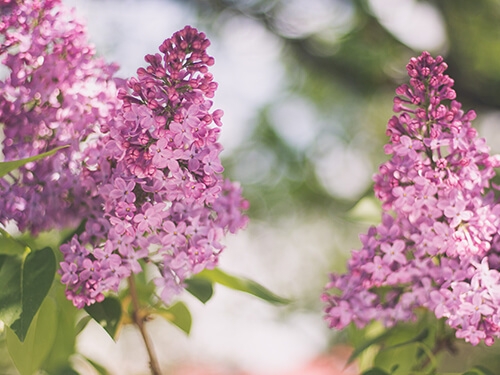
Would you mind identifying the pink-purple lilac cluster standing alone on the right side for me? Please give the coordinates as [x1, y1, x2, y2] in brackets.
[323, 52, 500, 345]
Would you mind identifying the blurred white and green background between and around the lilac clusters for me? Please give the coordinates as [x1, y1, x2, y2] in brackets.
[6, 0, 500, 375]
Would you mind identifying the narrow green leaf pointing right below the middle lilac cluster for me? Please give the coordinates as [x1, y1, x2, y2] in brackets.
[192, 268, 291, 305]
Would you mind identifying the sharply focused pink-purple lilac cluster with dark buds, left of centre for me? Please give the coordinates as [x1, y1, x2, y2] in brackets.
[61, 26, 247, 307]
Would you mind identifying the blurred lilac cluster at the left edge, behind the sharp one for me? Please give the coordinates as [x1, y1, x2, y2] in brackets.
[0, 0, 121, 234]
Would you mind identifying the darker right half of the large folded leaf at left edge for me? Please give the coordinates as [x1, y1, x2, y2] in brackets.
[10, 247, 56, 341]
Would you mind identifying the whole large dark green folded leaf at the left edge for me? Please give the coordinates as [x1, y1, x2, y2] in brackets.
[0, 248, 56, 341]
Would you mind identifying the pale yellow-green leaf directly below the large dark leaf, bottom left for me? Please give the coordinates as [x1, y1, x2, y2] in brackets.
[6, 297, 57, 375]
